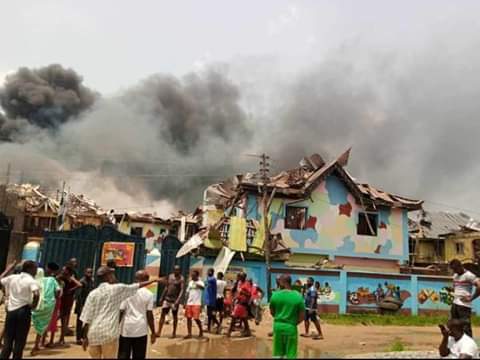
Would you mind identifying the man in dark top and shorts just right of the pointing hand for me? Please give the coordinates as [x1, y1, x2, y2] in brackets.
[157, 265, 185, 339]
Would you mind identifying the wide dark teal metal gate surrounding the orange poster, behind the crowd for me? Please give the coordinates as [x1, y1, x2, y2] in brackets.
[41, 225, 145, 283]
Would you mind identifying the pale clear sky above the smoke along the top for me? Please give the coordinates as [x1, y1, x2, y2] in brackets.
[0, 0, 480, 94]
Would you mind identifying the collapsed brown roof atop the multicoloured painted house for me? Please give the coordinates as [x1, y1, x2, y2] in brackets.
[205, 149, 423, 210]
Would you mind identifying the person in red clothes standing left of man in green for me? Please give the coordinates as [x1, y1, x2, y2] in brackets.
[227, 272, 252, 337]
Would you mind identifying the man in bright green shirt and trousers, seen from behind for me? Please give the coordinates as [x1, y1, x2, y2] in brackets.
[270, 275, 305, 359]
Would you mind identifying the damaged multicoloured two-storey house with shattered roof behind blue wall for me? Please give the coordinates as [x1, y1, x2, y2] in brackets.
[180, 150, 423, 308]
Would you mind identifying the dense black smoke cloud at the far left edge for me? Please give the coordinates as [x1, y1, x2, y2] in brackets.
[0, 64, 96, 135]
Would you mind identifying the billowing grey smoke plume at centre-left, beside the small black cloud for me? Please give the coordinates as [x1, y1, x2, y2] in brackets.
[0, 69, 252, 215]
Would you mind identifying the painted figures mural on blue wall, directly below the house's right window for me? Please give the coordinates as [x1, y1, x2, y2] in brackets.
[347, 282, 411, 305]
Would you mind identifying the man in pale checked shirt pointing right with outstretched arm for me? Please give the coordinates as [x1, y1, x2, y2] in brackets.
[80, 266, 164, 359]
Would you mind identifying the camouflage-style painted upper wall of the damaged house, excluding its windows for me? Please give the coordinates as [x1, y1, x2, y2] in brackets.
[247, 175, 408, 261]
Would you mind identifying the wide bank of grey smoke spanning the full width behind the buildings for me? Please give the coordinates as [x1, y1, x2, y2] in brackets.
[0, 38, 480, 215]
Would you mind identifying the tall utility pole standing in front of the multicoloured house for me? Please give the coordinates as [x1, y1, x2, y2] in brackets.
[260, 153, 272, 300]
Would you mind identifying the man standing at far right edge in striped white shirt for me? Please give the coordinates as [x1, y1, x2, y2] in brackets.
[450, 259, 480, 337]
